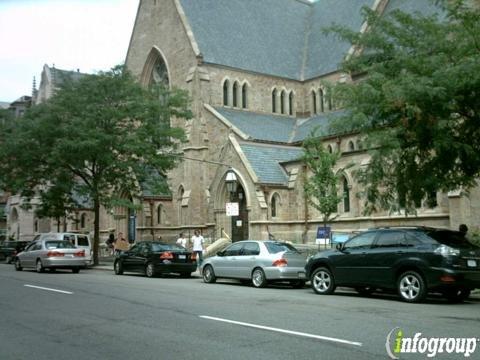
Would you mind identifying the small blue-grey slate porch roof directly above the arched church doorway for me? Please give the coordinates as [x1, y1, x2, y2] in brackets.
[240, 143, 303, 185]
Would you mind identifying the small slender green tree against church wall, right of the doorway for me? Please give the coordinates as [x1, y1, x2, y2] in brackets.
[303, 133, 343, 238]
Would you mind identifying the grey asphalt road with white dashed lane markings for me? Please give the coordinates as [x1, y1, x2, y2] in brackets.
[0, 264, 480, 360]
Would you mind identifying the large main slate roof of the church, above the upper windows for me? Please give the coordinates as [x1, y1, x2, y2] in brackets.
[180, 0, 374, 80]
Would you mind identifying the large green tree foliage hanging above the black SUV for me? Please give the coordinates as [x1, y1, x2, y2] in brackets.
[329, 0, 480, 212]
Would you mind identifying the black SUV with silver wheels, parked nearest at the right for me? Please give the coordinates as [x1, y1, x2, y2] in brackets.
[305, 227, 480, 302]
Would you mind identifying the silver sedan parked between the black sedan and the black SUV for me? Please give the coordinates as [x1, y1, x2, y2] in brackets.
[201, 240, 306, 287]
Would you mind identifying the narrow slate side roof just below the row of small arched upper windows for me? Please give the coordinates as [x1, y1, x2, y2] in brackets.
[215, 107, 344, 143]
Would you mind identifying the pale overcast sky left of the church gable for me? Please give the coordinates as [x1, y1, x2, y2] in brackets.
[0, 0, 139, 102]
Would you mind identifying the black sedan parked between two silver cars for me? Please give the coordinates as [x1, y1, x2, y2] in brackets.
[113, 241, 197, 277]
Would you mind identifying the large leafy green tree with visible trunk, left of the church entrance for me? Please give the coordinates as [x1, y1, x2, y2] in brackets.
[0, 67, 191, 264]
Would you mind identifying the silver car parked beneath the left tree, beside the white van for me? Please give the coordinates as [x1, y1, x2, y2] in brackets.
[14, 240, 85, 273]
